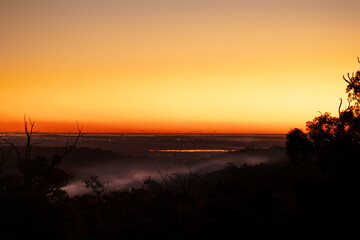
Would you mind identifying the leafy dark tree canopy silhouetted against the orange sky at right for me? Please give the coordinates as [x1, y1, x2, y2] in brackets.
[286, 58, 360, 175]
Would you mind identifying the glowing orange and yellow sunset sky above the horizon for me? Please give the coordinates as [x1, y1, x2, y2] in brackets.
[0, 0, 360, 133]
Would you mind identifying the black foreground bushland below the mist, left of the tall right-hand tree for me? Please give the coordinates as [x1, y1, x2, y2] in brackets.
[0, 151, 320, 239]
